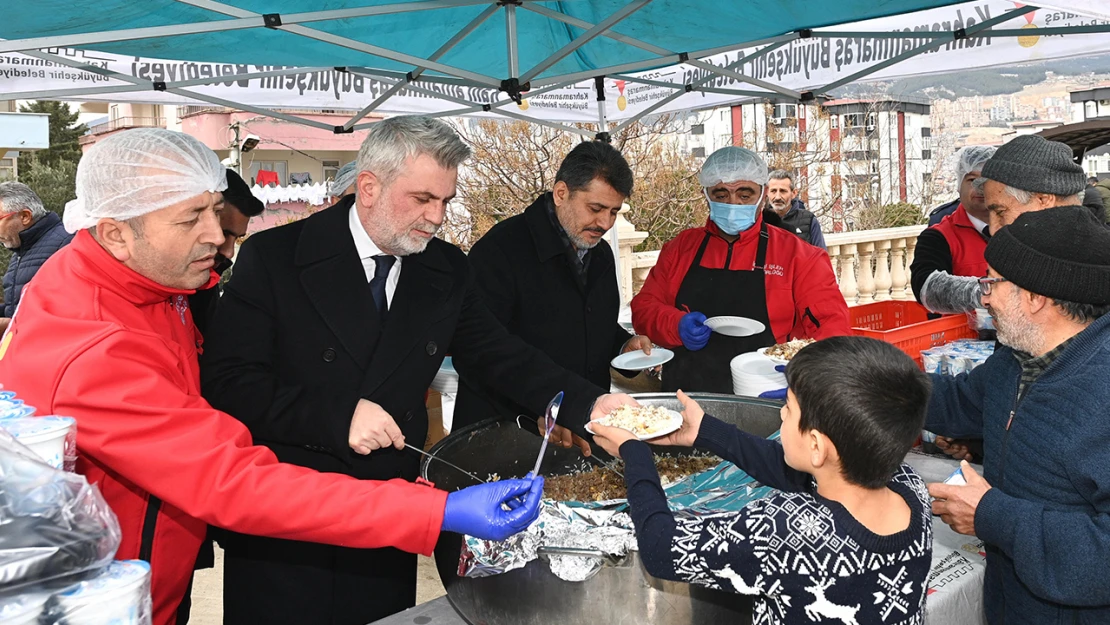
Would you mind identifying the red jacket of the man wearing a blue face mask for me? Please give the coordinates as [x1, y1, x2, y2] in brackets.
[632, 215, 851, 347]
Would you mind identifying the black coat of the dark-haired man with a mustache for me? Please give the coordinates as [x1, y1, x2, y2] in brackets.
[453, 193, 632, 429]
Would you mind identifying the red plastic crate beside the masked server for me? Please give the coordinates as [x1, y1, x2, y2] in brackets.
[848, 301, 979, 366]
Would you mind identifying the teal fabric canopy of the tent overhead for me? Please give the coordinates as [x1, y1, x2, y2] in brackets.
[0, 0, 959, 80]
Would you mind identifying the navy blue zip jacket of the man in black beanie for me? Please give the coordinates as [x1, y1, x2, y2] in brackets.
[925, 315, 1110, 625]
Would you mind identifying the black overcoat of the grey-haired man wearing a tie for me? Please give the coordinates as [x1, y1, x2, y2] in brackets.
[201, 198, 603, 625]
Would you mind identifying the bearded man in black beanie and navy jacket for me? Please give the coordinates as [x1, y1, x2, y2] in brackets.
[926, 206, 1110, 625]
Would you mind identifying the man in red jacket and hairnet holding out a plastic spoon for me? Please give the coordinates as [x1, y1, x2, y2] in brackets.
[0, 129, 543, 625]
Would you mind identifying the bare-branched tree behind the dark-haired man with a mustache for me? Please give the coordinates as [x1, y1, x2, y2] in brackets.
[444, 115, 706, 250]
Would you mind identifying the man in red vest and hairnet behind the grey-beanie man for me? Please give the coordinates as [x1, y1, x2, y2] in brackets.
[910, 145, 995, 313]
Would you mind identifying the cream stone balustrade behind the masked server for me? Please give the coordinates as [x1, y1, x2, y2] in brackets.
[620, 225, 925, 306]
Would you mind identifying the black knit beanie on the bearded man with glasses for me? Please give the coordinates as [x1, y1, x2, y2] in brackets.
[986, 206, 1110, 305]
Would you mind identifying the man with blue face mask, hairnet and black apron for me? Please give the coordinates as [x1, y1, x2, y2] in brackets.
[632, 147, 850, 393]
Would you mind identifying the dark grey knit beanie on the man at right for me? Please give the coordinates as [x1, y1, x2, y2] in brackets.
[982, 134, 1087, 196]
